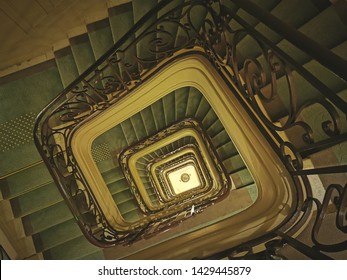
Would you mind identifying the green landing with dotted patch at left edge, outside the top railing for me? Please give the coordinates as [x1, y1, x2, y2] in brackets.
[0, 60, 63, 177]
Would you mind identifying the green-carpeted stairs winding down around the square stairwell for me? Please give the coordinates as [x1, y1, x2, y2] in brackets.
[0, 0, 347, 259]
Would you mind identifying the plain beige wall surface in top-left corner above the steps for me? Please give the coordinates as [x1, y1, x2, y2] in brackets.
[0, 0, 130, 76]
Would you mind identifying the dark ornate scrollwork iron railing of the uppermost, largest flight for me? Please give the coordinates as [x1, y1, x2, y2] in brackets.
[34, 0, 347, 258]
